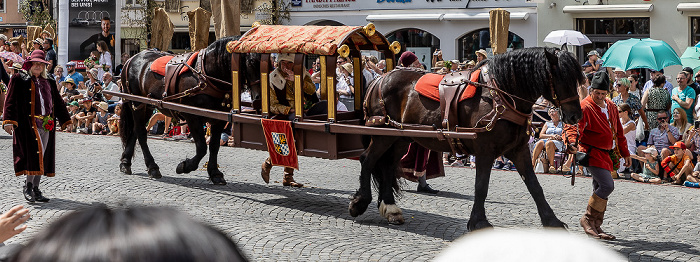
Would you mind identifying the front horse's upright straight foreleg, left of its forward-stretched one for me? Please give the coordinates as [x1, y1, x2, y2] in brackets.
[467, 153, 496, 231]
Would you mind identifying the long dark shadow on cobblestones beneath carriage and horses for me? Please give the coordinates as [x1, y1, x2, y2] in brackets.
[157, 176, 468, 241]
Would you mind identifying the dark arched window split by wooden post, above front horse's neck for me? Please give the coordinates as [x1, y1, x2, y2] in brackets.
[457, 28, 525, 62]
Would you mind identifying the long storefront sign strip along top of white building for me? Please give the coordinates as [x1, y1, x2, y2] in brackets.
[289, 0, 537, 11]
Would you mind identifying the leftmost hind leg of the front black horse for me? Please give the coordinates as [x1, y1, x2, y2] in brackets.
[348, 136, 397, 217]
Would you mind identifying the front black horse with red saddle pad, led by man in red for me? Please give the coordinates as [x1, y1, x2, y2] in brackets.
[349, 47, 583, 230]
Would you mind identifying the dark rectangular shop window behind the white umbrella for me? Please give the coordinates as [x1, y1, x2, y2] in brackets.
[576, 17, 649, 61]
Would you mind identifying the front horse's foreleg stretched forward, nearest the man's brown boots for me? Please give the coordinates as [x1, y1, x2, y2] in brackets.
[506, 144, 567, 228]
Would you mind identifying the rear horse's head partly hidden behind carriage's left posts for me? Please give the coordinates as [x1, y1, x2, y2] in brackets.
[205, 36, 261, 100]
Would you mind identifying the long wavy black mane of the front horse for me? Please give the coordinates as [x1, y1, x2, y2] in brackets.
[482, 47, 583, 101]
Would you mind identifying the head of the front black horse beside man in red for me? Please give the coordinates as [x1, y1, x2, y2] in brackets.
[544, 48, 584, 124]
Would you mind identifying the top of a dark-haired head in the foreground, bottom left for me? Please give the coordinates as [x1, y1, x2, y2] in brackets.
[13, 206, 246, 262]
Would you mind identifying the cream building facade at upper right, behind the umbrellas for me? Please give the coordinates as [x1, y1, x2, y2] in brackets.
[537, 0, 700, 81]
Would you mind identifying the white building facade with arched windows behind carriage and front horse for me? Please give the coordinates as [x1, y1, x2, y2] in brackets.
[289, 0, 538, 66]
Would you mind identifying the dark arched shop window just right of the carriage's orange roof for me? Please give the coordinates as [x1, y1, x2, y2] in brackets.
[386, 28, 440, 70]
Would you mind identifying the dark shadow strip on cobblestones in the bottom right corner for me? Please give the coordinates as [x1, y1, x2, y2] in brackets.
[609, 239, 700, 261]
